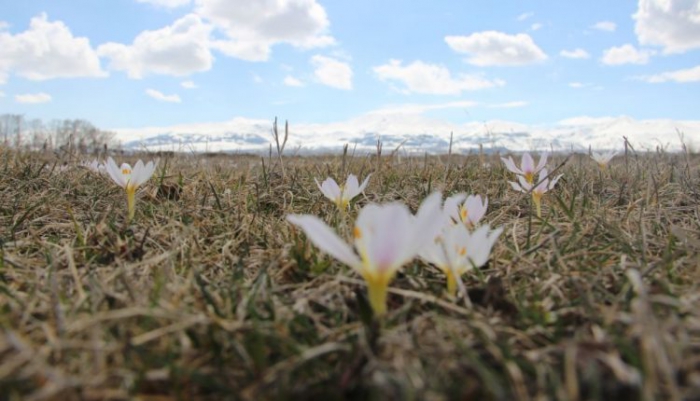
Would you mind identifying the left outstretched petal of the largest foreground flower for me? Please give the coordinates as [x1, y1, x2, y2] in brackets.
[287, 214, 362, 271]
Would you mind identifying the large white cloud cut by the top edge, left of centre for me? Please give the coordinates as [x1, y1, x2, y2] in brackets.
[196, 0, 335, 61]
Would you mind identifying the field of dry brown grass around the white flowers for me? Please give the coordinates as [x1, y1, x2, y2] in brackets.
[0, 145, 700, 400]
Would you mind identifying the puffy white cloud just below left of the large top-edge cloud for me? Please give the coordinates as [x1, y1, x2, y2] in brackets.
[97, 14, 214, 79]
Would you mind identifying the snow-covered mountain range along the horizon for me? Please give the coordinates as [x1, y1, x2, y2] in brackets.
[115, 113, 700, 154]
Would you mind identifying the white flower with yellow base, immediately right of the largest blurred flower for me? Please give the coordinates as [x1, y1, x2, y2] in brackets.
[420, 224, 503, 296]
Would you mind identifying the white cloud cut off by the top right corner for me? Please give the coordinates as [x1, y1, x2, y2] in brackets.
[632, 0, 700, 53]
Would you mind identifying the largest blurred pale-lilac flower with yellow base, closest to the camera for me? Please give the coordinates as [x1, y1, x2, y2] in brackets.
[287, 193, 444, 316]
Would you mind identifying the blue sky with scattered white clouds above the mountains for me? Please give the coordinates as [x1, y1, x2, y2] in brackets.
[0, 0, 700, 148]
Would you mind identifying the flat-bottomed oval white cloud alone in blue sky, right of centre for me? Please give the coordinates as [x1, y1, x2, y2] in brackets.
[445, 31, 547, 66]
